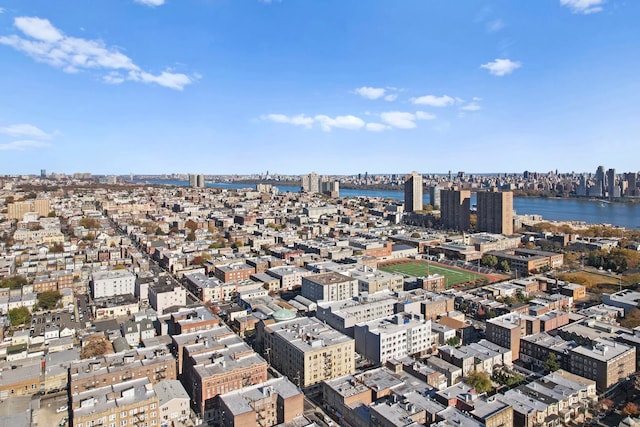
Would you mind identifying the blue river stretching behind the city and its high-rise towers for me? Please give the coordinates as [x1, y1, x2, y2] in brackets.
[135, 180, 640, 229]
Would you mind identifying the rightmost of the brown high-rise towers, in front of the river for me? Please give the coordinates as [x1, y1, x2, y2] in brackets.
[477, 191, 513, 235]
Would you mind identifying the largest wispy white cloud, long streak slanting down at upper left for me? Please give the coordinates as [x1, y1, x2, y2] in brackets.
[0, 17, 197, 90]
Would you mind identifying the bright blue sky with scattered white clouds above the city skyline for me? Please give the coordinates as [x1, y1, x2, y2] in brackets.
[0, 0, 640, 174]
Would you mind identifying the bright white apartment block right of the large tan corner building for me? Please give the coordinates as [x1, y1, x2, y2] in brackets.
[354, 313, 433, 363]
